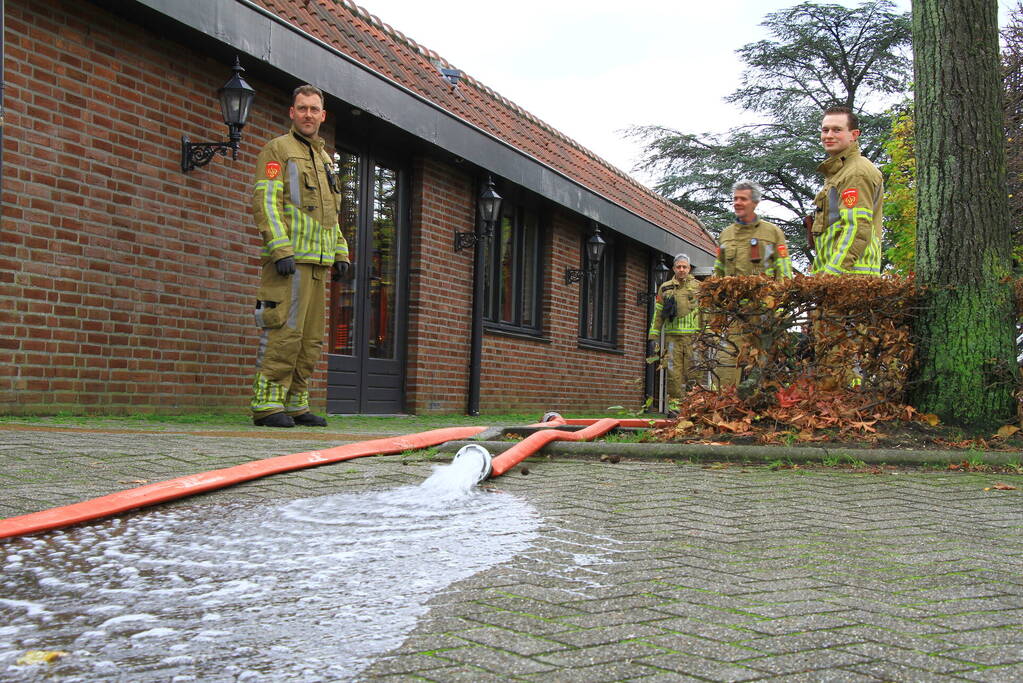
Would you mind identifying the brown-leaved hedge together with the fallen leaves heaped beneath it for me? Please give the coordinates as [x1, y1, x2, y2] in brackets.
[656, 275, 1023, 443]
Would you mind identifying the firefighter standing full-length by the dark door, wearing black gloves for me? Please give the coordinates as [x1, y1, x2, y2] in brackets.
[251, 85, 349, 427]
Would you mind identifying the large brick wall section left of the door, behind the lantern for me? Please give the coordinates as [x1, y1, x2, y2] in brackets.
[0, 0, 325, 413]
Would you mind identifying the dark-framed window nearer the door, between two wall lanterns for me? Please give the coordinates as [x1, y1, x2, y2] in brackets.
[483, 200, 543, 336]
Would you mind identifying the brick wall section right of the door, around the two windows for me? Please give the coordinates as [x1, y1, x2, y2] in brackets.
[407, 158, 648, 413]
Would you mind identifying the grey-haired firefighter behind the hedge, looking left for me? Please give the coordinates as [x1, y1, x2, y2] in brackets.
[714, 181, 792, 389]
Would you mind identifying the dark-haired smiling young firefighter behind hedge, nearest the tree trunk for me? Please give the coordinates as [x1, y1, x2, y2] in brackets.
[808, 106, 885, 277]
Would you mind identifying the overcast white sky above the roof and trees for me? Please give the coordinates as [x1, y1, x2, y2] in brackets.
[355, 0, 1015, 184]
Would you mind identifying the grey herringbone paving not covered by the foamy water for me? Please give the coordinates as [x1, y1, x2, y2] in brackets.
[0, 429, 1023, 683]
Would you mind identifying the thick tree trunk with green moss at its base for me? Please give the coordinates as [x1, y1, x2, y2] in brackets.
[913, 0, 1019, 428]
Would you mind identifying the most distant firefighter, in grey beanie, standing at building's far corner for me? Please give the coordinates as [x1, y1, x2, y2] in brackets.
[647, 254, 700, 400]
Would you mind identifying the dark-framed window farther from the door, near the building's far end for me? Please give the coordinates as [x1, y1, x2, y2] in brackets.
[579, 235, 618, 349]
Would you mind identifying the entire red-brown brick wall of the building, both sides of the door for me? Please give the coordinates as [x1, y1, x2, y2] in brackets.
[0, 0, 646, 413]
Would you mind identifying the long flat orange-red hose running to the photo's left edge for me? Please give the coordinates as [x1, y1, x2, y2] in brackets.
[0, 426, 487, 539]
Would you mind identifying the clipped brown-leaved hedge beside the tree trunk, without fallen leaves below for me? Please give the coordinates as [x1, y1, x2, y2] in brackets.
[696, 275, 918, 408]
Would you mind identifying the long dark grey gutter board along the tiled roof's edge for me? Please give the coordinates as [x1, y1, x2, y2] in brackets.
[127, 0, 714, 266]
